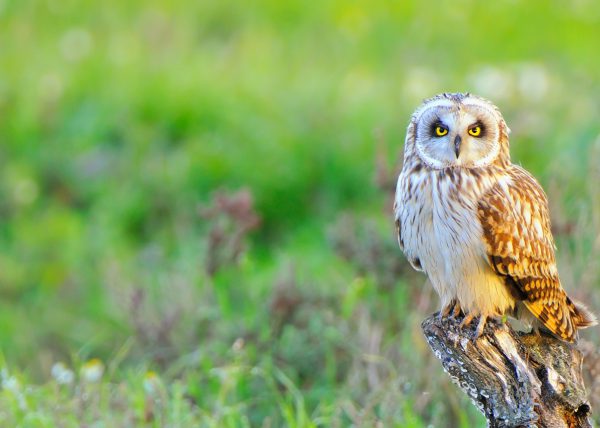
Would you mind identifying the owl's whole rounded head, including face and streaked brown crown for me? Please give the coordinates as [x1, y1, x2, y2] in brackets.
[405, 93, 510, 169]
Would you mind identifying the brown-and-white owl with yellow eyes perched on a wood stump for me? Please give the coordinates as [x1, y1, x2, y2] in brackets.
[394, 93, 597, 342]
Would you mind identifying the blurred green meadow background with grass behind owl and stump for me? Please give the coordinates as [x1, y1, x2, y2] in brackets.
[0, 0, 600, 427]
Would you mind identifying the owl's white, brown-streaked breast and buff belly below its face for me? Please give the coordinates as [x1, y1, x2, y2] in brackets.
[396, 171, 512, 313]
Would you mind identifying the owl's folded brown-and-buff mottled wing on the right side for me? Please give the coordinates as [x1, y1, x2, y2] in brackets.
[478, 166, 585, 341]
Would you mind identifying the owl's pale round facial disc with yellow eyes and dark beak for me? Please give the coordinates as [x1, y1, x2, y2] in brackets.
[416, 103, 500, 169]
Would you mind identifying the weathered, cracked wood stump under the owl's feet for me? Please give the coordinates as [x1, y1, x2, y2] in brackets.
[422, 314, 592, 428]
